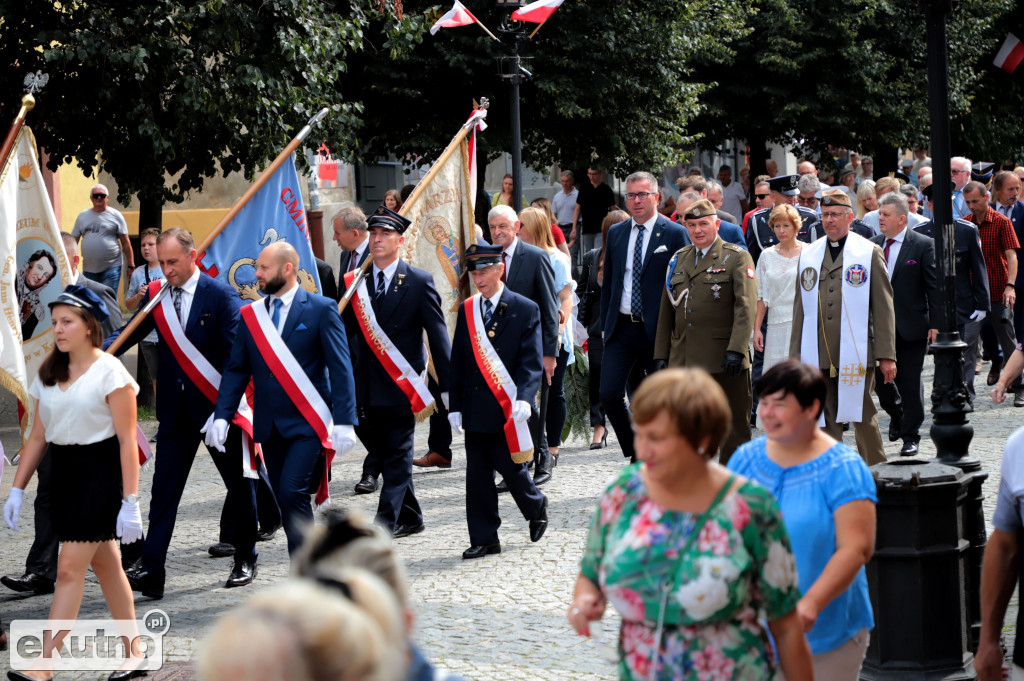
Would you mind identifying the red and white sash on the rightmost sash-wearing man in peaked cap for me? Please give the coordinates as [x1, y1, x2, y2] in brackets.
[463, 294, 534, 464]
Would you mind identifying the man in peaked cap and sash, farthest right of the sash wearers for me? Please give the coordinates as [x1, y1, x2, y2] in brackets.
[449, 244, 548, 559]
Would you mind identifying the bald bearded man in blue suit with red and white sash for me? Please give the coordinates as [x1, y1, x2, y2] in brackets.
[207, 242, 356, 555]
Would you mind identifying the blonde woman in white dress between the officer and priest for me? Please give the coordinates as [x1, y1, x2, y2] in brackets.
[754, 205, 802, 372]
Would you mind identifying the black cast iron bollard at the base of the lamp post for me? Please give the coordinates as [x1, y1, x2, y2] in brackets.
[860, 459, 976, 681]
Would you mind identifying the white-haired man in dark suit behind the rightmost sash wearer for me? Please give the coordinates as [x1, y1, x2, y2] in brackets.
[487, 205, 559, 483]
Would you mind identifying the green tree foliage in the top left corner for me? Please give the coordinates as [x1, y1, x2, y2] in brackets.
[0, 0, 367, 215]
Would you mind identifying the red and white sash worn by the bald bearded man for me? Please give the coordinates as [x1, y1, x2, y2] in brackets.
[242, 300, 334, 508]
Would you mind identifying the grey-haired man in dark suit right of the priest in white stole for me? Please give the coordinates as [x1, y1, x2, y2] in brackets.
[871, 191, 939, 457]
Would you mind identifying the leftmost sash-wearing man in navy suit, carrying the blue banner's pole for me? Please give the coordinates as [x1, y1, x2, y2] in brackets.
[104, 227, 257, 598]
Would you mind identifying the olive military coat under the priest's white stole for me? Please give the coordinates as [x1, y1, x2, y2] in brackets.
[790, 237, 896, 366]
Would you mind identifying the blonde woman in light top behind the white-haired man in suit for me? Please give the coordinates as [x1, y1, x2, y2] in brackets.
[519, 208, 575, 456]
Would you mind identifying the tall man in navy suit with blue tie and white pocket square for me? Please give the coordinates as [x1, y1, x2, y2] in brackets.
[601, 172, 690, 460]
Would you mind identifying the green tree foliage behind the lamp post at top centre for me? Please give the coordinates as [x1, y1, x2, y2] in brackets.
[331, 0, 745, 178]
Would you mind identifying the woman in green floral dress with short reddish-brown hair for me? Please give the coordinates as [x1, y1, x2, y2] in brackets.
[568, 369, 813, 681]
